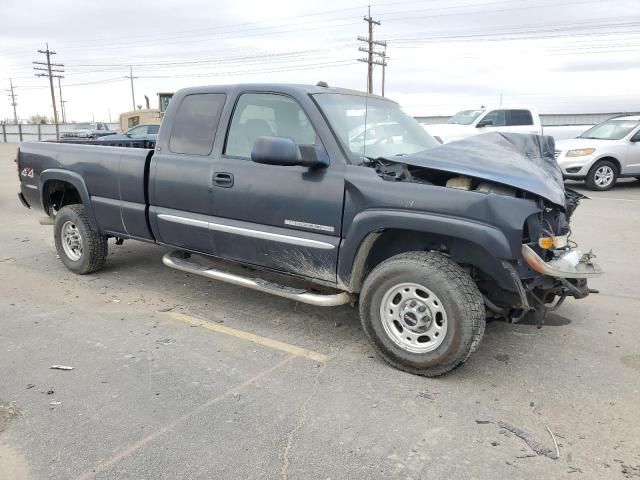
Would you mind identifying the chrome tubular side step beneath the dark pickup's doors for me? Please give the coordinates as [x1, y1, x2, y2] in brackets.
[162, 252, 351, 307]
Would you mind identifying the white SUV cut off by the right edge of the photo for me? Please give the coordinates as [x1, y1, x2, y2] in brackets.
[556, 115, 640, 190]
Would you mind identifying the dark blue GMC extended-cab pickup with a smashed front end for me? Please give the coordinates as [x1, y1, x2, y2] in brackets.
[16, 83, 602, 376]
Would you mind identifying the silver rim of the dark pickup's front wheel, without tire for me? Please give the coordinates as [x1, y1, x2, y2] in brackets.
[380, 283, 448, 353]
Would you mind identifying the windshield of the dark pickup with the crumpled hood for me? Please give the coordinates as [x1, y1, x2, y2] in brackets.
[314, 93, 439, 162]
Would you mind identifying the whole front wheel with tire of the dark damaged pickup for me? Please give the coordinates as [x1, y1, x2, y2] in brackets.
[360, 252, 486, 377]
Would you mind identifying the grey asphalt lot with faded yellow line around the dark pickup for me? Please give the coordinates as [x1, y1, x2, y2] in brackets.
[0, 145, 640, 479]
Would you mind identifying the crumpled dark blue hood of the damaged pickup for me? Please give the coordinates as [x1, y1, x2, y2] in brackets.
[384, 132, 565, 208]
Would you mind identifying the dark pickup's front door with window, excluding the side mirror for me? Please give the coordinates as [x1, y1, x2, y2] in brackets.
[209, 91, 345, 282]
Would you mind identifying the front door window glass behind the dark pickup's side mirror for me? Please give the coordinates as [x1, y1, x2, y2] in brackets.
[224, 93, 320, 158]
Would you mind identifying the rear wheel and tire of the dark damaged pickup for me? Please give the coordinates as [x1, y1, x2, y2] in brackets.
[53, 204, 108, 275]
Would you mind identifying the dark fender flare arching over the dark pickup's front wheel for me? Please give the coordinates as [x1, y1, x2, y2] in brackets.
[338, 209, 519, 291]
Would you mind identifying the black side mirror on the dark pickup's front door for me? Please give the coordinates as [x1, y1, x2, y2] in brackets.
[251, 137, 329, 168]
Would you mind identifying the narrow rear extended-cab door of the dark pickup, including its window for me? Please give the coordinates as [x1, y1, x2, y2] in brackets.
[149, 93, 226, 254]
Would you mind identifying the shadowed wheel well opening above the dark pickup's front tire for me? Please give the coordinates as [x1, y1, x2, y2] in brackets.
[350, 229, 509, 292]
